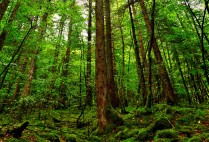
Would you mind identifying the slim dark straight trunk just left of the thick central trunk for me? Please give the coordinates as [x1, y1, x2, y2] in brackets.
[86, 0, 92, 106]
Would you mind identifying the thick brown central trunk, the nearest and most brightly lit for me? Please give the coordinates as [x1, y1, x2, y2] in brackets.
[95, 0, 108, 130]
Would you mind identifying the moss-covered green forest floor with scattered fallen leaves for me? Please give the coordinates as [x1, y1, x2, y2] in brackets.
[0, 104, 209, 142]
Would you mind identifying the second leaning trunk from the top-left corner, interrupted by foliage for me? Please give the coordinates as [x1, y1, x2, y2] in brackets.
[0, 2, 20, 51]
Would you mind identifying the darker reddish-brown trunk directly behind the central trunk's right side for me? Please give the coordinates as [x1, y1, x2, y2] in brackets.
[105, 0, 119, 108]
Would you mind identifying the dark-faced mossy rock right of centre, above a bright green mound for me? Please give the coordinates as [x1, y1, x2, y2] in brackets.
[152, 118, 172, 132]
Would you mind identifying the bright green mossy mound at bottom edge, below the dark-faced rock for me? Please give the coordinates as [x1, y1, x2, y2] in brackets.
[154, 129, 179, 141]
